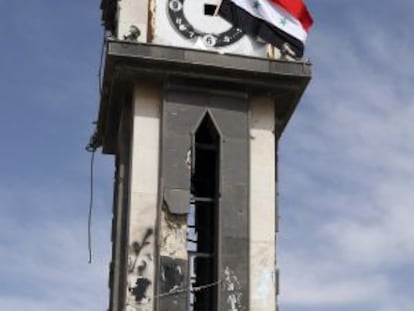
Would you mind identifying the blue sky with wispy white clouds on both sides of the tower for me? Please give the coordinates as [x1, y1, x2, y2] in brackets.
[0, 0, 414, 311]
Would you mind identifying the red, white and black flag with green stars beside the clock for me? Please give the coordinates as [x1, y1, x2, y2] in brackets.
[217, 0, 313, 58]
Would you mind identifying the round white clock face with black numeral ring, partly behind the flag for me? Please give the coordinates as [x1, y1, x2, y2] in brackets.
[167, 0, 244, 48]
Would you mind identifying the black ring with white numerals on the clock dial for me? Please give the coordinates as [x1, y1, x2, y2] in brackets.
[167, 0, 244, 48]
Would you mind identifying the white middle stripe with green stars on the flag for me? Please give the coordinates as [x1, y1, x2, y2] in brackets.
[230, 0, 308, 42]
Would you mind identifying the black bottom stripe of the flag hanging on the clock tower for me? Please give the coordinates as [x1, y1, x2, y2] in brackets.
[218, 0, 305, 58]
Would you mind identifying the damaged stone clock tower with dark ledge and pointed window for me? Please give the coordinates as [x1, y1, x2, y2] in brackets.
[96, 0, 310, 311]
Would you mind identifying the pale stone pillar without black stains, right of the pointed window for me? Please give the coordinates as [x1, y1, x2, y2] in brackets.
[249, 97, 276, 311]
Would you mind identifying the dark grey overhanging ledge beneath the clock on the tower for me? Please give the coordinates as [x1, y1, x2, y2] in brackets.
[98, 39, 311, 154]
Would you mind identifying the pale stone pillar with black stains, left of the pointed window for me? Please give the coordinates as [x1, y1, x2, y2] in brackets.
[126, 83, 162, 311]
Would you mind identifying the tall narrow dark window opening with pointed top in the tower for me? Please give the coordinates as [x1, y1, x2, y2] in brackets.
[187, 114, 220, 311]
